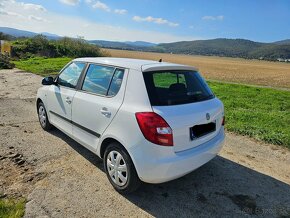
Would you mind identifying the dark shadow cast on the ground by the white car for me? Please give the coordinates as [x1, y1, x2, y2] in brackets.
[47, 130, 290, 217]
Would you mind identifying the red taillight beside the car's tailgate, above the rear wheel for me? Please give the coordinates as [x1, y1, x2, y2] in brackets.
[136, 112, 173, 146]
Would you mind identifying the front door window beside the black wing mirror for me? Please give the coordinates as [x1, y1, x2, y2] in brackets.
[57, 62, 86, 88]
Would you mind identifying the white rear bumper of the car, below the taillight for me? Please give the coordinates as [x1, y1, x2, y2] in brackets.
[130, 128, 225, 183]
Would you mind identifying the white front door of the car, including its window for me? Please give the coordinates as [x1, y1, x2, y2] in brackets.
[47, 62, 86, 135]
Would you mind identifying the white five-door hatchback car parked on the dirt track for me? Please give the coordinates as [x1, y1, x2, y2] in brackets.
[37, 58, 225, 193]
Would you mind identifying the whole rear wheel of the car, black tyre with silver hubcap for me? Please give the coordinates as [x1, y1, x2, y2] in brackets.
[103, 142, 141, 194]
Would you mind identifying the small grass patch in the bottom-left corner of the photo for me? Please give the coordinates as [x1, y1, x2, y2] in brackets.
[0, 199, 25, 218]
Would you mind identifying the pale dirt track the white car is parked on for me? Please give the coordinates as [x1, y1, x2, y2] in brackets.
[0, 70, 290, 217]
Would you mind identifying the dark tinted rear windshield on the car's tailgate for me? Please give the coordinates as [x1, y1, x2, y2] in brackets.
[143, 71, 214, 106]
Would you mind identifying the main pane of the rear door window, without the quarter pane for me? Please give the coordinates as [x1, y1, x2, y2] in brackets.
[82, 64, 115, 95]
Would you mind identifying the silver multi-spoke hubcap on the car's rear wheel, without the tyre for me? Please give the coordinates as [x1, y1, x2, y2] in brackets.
[107, 151, 128, 186]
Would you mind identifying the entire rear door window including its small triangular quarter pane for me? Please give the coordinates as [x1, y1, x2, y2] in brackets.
[82, 64, 124, 96]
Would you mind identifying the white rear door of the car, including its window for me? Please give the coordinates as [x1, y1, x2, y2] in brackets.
[72, 64, 127, 152]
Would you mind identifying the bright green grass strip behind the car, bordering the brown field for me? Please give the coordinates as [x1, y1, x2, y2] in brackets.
[14, 58, 290, 148]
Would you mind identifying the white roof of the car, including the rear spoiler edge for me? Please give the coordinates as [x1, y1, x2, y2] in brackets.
[73, 57, 198, 72]
